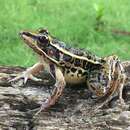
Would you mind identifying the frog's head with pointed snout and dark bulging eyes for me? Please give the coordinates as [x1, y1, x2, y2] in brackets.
[20, 29, 51, 53]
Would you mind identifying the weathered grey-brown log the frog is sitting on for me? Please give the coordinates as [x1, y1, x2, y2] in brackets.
[0, 62, 130, 130]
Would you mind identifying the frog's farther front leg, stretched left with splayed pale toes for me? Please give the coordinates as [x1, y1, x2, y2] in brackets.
[10, 62, 44, 84]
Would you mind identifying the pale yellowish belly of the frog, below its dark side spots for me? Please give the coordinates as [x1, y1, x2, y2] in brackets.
[64, 74, 86, 84]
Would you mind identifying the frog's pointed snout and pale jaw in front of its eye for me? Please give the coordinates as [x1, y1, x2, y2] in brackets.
[19, 31, 43, 55]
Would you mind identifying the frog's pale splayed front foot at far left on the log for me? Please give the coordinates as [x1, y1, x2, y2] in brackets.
[9, 71, 42, 84]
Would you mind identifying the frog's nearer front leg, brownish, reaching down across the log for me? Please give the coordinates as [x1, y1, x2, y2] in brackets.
[36, 66, 66, 115]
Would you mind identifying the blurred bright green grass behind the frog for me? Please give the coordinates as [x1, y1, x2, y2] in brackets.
[0, 0, 130, 66]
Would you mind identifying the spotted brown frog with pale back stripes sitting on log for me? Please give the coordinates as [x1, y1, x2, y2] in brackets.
[10, 28, 126, 112]
